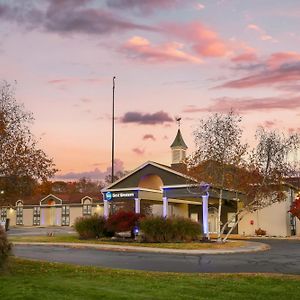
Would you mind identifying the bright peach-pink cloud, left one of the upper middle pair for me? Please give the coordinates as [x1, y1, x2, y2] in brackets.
[121, 36, 202, 64]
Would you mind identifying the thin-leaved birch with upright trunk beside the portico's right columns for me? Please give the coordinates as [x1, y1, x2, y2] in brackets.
[188, 111, 247, 237]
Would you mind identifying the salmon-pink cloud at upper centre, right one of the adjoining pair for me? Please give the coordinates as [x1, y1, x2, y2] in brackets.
[162, 22, 231, 57]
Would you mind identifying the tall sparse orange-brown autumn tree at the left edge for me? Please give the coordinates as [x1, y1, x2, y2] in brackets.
[0, 81, 56, 204]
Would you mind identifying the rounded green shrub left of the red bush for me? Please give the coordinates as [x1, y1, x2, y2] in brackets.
[74, 214, 107, 239]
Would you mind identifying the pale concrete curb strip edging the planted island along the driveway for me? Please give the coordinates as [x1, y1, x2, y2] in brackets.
[13, 241, 270, 255]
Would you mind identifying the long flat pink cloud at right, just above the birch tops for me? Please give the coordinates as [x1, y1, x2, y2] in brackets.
[183, 96, 300, 113]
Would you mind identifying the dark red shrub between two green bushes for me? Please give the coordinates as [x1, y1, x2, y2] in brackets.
[106, 211, 142, 233]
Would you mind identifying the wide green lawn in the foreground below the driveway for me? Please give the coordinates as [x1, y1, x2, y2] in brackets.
[0, 258, 300, 300]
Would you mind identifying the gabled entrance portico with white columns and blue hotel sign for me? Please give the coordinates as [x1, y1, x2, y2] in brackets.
[102, 162, 239, 234]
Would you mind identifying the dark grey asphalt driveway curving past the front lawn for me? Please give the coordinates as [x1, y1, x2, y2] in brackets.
[14, 240, 300, 274]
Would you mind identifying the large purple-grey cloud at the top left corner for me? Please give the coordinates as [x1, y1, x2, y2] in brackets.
[0, 0, 155, 35]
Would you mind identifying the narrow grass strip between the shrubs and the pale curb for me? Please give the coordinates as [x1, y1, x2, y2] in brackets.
[9, 235, 247, 250]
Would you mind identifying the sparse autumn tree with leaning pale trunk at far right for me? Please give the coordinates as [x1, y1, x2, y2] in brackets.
[222, 127, 300, 240]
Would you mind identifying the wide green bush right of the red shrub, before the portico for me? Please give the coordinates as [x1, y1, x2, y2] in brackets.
[140, 217, 201, 243]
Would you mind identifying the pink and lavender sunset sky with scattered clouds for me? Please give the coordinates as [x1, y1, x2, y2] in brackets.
[0, 0, 300, 180]
